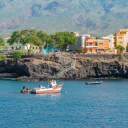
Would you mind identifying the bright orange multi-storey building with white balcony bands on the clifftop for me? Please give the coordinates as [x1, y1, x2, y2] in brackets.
[82, 37, 110, 53]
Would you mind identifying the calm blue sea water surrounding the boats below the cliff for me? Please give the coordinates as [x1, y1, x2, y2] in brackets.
[0, 79, 128, 128]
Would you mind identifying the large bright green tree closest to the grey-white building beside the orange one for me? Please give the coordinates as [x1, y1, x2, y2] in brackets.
[55, 32, 77, 51]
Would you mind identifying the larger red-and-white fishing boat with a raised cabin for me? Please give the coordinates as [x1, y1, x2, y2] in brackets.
[31, 80, 63, 94]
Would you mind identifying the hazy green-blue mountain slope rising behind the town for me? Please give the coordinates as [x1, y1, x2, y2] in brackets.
[0, 0, 128, 37]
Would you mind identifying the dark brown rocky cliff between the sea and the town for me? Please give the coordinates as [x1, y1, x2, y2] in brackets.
[0, 53, 128, 81]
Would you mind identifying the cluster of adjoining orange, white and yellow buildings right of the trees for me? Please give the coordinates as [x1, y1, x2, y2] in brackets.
[69, 29, 128, 53]
